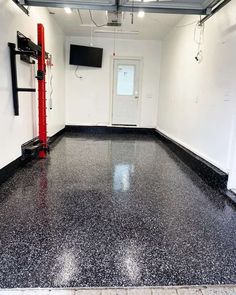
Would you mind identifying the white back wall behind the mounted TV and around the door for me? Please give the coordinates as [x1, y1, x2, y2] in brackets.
[66, 37, 161, 127]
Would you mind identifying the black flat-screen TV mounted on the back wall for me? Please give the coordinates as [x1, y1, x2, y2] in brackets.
[70, 44, 103, 68]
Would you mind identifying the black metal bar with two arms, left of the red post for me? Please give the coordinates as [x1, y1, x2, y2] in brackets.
[8, 43, 36, 116]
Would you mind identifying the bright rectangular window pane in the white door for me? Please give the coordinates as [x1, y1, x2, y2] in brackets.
[116, 65, 135, 95]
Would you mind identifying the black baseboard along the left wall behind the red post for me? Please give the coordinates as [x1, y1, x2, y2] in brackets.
[0, 128, 65, 185]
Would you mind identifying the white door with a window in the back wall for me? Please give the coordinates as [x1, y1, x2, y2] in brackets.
[112, 59, 140, 126]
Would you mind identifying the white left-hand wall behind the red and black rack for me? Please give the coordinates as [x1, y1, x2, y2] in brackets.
[0, 0, 65, 168]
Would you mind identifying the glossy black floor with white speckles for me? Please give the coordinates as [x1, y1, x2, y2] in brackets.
[0, 134, 236, 288]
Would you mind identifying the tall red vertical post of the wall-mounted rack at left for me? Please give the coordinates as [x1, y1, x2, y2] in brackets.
[37, 24, 47, 158]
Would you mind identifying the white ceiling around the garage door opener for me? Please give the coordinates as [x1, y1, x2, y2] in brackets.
[49, 8, 183, 40]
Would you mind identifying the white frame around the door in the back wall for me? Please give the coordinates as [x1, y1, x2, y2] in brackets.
[109, 56, 143, 127]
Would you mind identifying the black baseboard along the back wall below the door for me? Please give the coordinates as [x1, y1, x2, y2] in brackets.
[65, 125, 155, 135]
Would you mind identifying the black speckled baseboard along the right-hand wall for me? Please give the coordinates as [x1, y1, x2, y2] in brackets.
[155, 130, 228, 190]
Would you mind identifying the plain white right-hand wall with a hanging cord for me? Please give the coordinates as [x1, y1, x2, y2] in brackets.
[157, 1, 236, 176]
